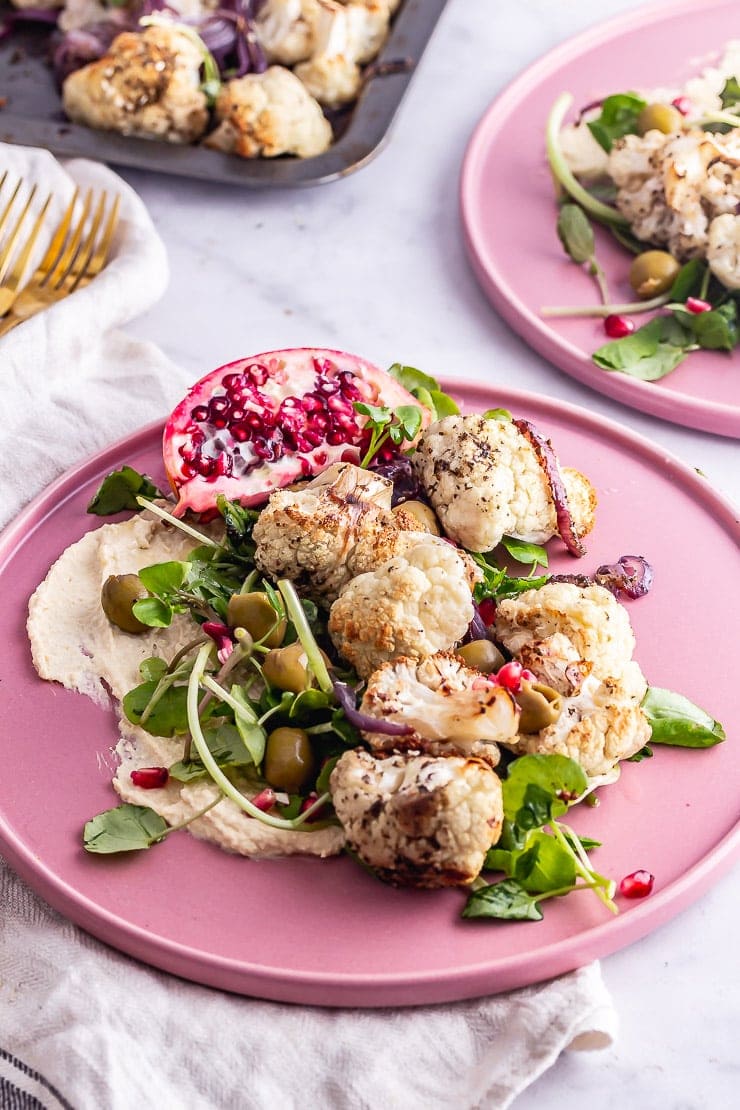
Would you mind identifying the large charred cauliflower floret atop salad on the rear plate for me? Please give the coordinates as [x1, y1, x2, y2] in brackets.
[609, 128, 740, 264]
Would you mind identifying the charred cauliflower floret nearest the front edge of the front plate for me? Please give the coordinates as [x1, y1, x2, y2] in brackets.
[330, 750, 504, 888]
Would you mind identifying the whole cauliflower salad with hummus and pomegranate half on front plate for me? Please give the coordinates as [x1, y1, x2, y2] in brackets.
[28, 349, 724, 920]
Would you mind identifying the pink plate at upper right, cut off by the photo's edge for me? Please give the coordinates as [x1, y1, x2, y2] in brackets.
[460, 0, 740, 437]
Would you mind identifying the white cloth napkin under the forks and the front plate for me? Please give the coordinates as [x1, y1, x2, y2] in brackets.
[0, 144, 616, 1110]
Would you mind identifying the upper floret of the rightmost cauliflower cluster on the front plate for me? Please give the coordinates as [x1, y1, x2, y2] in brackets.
[495, 582, 635, 678]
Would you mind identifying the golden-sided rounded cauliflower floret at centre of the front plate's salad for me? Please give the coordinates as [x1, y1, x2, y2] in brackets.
[328, 536, 474, 677]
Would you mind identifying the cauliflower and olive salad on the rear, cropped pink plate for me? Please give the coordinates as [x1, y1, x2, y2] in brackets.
[541, 41, 740, 381]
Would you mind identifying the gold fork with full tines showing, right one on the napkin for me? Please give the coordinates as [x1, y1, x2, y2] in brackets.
[0, 189, 120, 336]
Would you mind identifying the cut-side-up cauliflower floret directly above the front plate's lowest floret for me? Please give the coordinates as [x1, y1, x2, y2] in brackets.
[361, 652, 519, 767]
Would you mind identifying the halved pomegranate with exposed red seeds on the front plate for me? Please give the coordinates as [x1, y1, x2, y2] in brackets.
[162, 347, 432, 516]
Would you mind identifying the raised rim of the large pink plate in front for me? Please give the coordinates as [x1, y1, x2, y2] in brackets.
[0, 395, 740, 1008]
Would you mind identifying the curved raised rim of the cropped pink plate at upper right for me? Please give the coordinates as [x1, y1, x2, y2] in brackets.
[459, 0, 740, 438]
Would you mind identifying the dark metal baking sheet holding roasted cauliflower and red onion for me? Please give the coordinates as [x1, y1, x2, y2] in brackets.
[0, 0, 446, 189]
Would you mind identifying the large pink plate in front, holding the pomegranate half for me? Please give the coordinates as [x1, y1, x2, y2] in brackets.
[0, 383, 740, 1006]
